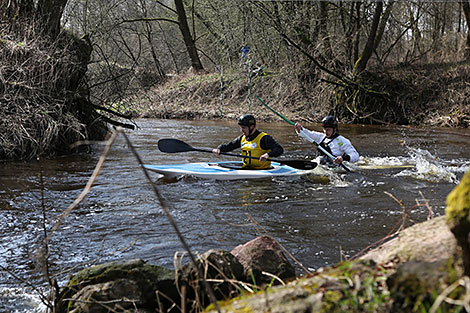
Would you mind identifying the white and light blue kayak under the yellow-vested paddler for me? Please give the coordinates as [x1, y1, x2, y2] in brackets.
[144, 162, 312, 180]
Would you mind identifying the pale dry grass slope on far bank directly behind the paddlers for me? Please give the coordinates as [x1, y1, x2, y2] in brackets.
[133, 67, 330, 122]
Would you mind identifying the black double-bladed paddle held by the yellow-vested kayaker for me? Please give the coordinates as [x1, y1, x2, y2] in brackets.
[158, 139, 317, 170]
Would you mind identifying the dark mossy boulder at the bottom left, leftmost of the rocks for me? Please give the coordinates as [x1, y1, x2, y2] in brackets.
[56, 259, 179, 313]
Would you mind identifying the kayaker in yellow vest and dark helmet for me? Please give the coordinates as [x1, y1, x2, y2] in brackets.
[212, 114, 284, 169]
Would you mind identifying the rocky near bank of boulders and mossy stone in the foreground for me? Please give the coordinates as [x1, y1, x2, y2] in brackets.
[58, 183, 470, 313]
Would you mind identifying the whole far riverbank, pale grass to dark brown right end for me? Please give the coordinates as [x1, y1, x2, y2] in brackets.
[130, 63, 470, 127]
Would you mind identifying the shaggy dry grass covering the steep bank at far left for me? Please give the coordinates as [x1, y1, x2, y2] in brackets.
[0, 23, 105, 159]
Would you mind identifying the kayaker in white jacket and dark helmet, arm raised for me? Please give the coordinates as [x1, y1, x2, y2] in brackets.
[294, 115, 359, 164]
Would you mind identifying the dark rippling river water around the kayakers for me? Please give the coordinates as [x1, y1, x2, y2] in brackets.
[0, 119, 470, 312]
